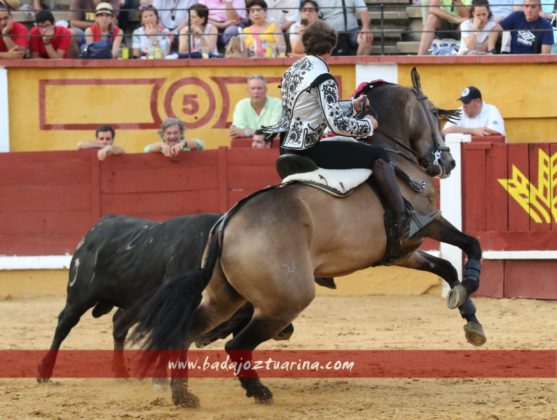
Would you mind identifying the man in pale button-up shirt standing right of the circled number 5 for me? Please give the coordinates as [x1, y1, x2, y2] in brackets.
[230, 75, 282, 138]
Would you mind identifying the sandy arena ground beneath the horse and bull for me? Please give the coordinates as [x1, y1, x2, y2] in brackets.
[0, 295, 557, 420]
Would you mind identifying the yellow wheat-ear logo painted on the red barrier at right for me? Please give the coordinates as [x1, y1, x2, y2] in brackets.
[498, 149, 557, 223]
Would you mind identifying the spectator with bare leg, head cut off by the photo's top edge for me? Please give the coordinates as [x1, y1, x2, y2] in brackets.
[418, 0, 472, 55]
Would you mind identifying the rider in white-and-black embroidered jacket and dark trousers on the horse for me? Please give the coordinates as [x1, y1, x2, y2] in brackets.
[265, 21, 410, 249]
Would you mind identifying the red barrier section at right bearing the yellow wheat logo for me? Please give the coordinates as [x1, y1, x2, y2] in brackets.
[462, 142, 557, 299]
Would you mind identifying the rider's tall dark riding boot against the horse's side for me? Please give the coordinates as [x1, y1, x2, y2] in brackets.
[373, 159, 410, 244]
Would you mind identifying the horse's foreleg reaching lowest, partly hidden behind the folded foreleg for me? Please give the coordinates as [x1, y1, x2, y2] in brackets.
[400, 251, 486, 346]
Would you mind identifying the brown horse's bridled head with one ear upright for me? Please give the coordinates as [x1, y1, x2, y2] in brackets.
[367, 69, 455, 178]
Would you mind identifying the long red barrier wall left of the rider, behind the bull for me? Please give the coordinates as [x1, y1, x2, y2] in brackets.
[0, 148, 279, 255]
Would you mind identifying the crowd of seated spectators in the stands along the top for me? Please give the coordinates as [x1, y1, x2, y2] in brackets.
[0, 0, 555, 59]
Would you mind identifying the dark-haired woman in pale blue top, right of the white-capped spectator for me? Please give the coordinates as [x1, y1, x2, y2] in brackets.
[132, 5, 172, 57]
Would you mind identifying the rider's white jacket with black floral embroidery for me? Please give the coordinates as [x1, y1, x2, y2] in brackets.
[265, 56, 373, 150]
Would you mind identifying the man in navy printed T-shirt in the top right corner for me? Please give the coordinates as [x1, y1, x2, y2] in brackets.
[494, 0, 553, 54]
